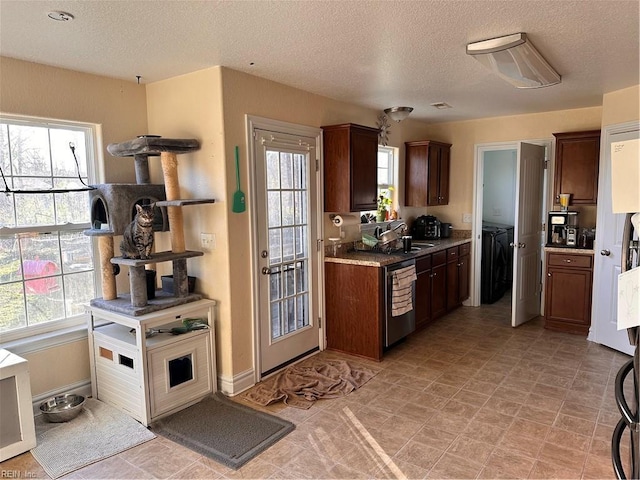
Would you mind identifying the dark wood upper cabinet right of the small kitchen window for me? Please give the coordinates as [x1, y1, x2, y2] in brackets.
[404, 140, 451, 207]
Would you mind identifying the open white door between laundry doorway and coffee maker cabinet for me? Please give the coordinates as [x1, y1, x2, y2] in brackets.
[511, 143, 545, 327]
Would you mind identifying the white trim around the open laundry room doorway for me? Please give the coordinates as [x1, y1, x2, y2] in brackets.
[469, 138, 554, 308]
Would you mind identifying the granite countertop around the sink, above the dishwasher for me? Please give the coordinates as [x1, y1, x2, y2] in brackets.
[324, 238, 471, 267]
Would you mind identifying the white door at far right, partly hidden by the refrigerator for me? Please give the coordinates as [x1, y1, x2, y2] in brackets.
[589, 122, 640, 355]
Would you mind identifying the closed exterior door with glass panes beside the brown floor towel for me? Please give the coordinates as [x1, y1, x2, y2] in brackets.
[254, 130, 320, 375]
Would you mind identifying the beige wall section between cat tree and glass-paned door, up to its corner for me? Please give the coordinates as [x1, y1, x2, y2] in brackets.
[147, 67, 232, 372]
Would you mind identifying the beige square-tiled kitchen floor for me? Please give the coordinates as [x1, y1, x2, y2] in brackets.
[0, 294, 629, 479]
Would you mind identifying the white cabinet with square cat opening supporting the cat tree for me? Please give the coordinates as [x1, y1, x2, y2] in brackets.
[89, 300, 216, 425]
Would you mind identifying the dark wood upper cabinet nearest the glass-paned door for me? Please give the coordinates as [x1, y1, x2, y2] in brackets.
[322, 123, 378, 212]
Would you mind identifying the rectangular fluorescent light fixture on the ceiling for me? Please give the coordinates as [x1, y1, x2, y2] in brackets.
[467, 33, 560, 88]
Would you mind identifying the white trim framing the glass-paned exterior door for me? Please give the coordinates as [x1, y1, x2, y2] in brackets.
[245, 115, 325, 383]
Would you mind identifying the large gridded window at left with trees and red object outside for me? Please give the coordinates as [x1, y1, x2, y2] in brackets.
[0, 115, 97, 342]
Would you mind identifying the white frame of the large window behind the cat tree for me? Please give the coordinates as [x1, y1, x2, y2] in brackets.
[0, 113, 104, 346]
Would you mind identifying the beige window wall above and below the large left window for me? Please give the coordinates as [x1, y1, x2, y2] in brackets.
[0, 57, 147, 396]
